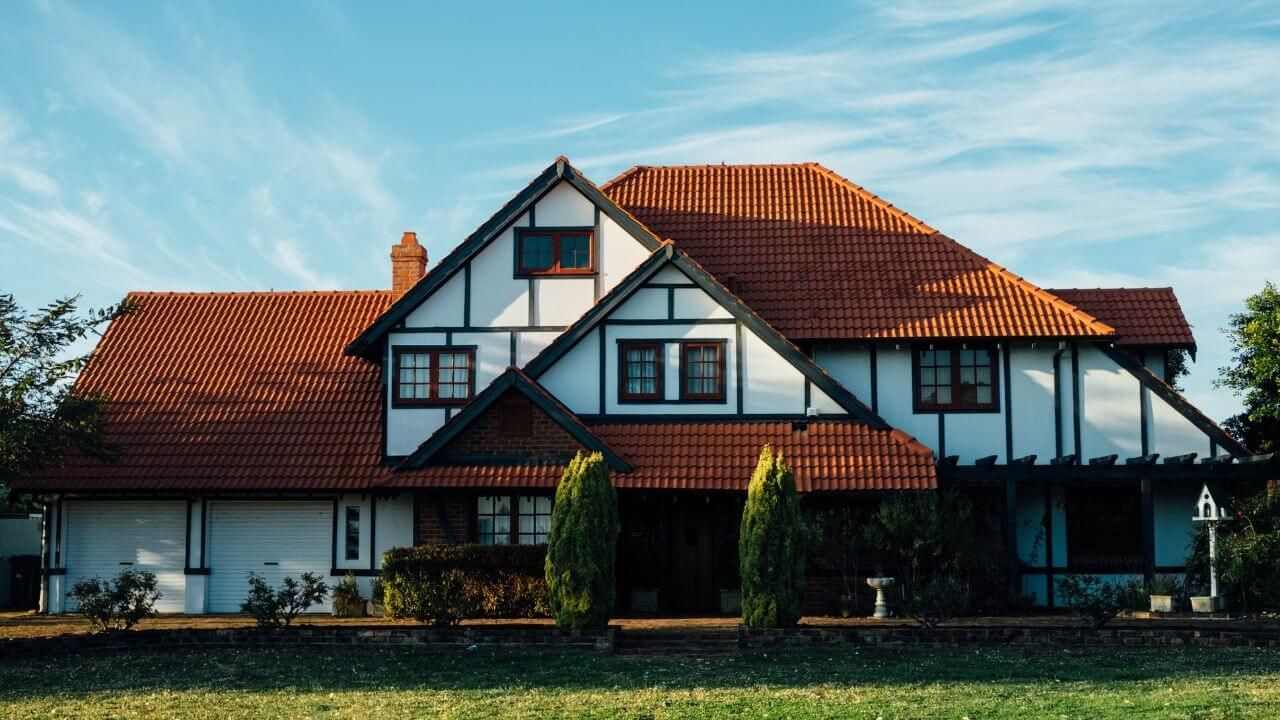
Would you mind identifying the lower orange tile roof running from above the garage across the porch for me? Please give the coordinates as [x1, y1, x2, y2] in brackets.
[15, 291, 936, 492]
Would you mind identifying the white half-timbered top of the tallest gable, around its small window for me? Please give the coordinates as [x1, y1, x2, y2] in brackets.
[346, 158, 659, 359]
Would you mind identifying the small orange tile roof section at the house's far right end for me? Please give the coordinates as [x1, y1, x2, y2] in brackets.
[1048, 287, 1196, 347]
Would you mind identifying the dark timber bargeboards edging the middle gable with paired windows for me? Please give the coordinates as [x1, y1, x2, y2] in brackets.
[525, 243, 890, 429]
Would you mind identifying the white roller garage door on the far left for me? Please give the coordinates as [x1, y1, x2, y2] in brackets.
[63, 500, 187, 612]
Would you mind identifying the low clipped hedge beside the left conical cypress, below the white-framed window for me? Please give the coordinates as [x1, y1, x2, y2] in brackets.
[383, 544, 548, 625]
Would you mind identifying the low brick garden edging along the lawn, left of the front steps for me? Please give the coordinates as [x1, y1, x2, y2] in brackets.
[0, 625, 618, 659]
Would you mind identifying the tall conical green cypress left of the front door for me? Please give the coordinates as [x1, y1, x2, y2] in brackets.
[547, 452, 620, 630]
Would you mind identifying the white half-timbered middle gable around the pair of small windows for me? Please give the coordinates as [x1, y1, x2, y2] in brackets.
[526, 246, 883, 427]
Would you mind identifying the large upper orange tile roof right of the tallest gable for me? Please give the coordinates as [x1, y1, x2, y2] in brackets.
[600, 163, 1111, 341]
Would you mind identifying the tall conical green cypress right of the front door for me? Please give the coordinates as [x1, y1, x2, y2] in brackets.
[739, 445, 806, 628]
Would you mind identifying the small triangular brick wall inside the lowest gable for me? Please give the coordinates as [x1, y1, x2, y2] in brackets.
[440, 391, 582, 461]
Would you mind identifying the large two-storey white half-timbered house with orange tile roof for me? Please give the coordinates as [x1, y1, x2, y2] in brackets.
[20, 158, 1267, 612]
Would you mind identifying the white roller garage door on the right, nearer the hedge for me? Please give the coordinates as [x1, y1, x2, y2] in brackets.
[207, 501, 333, 612]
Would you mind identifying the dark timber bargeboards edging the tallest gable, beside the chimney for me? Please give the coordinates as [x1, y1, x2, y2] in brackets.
[346, 158, 662, 359]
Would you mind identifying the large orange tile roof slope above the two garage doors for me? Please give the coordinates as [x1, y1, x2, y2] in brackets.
[20, 291, 390, 491]
